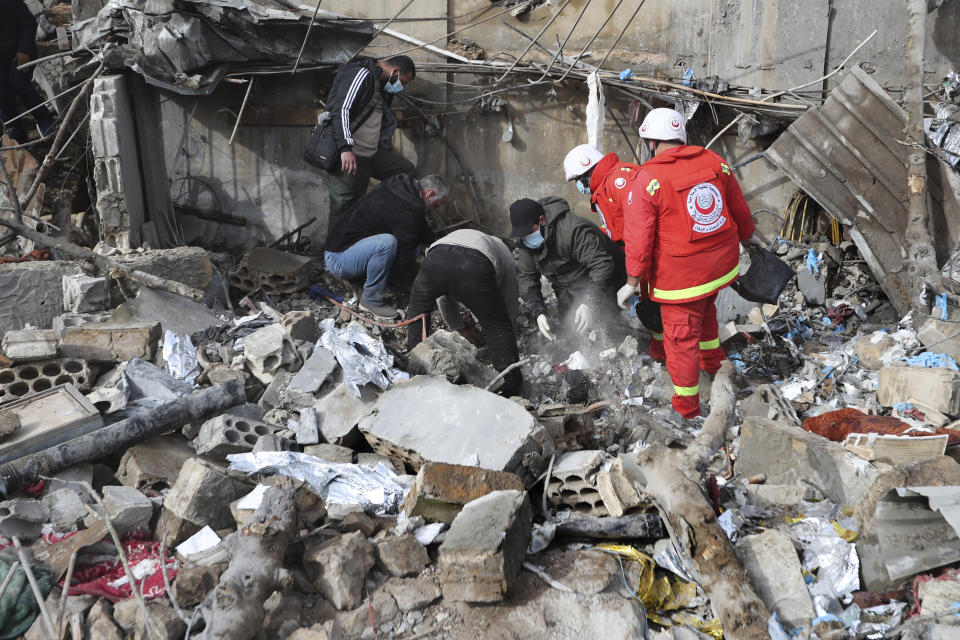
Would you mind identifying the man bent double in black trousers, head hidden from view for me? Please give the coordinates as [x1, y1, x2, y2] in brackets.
[407, 229, 523, 396]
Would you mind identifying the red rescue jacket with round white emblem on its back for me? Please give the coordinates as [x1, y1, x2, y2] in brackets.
[623, 146, 754, 303]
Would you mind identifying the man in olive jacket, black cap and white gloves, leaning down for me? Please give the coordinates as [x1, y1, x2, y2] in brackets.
[510, 196, 626, 340]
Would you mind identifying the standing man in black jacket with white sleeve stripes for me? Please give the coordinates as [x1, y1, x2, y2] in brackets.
[327, 56, 417, 229]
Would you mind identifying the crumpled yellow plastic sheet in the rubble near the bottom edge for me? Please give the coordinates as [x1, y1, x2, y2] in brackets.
[595, 544, 723, 640]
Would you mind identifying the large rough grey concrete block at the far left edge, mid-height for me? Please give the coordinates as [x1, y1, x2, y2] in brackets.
[0, 260, 83, 334]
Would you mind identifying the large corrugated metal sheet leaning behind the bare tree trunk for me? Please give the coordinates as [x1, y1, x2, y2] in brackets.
[765, 68, 960, 313]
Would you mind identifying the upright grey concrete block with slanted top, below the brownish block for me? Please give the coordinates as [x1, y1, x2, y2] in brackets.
[438, 491, 532, 602]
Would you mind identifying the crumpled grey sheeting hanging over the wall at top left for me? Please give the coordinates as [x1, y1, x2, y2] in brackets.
[67, 0, 374, 95]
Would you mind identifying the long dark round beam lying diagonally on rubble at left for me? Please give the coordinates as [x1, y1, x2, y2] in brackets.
[0, 380, 246, 497]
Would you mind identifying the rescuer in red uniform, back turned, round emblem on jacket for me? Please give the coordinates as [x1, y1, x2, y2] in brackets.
[614, 109, 760, 418]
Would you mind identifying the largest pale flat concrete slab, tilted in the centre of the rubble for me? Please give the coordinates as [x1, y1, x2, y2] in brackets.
[358, 376, 543, 471]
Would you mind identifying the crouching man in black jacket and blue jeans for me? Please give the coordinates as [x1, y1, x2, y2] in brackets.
[323, 175, 450, 318]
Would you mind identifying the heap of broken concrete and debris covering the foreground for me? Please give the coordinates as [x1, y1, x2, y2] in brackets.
[0, 235, 960, 638]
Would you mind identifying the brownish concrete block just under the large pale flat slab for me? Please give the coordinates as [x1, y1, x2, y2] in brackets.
[403, 462, 524, 524]
